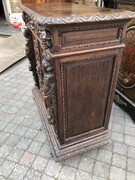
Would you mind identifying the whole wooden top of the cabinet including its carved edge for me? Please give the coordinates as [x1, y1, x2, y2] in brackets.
[20, 3, 135, 24]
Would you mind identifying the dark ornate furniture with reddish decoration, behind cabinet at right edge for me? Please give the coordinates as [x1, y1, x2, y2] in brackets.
[115, 0, 135, 122]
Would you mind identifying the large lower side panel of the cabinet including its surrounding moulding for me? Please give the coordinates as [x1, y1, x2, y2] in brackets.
[57, 52, 118, 143]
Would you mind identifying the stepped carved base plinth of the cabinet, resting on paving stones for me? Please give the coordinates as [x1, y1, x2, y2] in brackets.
[33, 88, 111, 162]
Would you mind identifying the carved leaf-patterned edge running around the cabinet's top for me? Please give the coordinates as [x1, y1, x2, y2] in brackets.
[19, 4, 135, 25]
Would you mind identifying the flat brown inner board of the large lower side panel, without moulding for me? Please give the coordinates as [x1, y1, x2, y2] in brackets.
[63, 56, 114, 138]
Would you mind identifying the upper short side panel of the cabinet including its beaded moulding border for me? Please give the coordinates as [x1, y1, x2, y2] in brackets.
[57, 22, 123, 52]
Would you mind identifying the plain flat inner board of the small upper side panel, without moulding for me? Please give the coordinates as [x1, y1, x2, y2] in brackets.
[61, 28, 118, 48]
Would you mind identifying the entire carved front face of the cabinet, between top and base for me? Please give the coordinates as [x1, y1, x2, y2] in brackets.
[23, 9, 57, 130]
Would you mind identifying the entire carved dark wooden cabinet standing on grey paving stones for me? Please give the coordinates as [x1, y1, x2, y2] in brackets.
[20, 3, 135, 161]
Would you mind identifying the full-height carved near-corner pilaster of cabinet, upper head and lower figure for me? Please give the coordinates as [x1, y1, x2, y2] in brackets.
[39, 26, 56, 128]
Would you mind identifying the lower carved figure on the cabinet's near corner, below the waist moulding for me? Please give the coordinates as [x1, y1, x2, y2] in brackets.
[42, 53, 56, 124]
